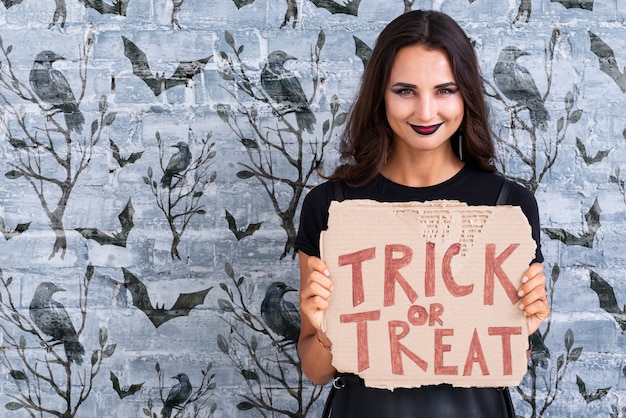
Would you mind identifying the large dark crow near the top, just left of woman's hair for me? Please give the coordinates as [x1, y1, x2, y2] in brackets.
[261, 51, 316, 133]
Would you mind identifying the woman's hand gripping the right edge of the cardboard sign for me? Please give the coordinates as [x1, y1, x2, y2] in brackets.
[517, 263, 550, 335]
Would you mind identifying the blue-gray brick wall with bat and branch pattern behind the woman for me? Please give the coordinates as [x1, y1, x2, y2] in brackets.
[0, 0, 626, 417]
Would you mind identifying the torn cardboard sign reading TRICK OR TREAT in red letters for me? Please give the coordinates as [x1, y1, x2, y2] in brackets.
[320, 200, 536, 389]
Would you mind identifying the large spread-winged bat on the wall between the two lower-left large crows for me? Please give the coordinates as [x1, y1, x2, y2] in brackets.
[122, 268, 213, 328]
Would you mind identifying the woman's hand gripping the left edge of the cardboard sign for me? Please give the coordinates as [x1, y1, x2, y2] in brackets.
[300, 256, 333, 332]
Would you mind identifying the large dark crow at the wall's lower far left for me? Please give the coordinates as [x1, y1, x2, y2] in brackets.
[29, 282, 85, 364]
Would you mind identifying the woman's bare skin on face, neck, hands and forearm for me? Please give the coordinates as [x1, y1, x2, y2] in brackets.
[298, 45, 550, 385]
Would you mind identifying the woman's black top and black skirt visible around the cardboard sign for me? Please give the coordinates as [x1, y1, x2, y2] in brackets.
[295, 165, 543, 418]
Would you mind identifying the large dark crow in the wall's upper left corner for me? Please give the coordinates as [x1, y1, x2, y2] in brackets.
[29, 50, 85, 134]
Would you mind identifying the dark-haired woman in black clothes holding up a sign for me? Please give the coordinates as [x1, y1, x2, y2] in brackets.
[296, 10, 550, 418]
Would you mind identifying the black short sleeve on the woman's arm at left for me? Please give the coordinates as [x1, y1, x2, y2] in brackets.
[294, 182, 332, 257]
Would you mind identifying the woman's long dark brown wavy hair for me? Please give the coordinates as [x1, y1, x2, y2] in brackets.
[329, 10, 496, 185]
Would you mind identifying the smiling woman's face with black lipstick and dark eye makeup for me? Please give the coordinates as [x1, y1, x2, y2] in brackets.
[385, 45, 464, 158]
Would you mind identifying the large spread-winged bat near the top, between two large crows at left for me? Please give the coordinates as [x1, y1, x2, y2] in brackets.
[122, 36, 212, 96]
